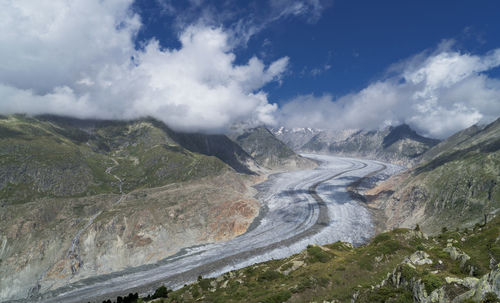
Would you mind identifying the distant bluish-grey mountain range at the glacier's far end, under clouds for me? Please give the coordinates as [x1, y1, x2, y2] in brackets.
[274, 124, 439, 166]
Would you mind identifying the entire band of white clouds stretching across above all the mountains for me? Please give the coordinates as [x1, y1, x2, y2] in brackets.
[0, 0, 500, 138]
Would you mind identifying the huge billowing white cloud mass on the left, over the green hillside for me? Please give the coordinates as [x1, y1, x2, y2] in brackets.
[0, 0, 288, 132]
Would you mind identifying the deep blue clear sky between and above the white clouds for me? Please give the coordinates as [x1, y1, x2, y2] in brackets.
[134, 0, 500, 103]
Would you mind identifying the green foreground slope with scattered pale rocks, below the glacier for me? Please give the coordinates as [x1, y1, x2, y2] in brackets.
[131, 217, 500, 303]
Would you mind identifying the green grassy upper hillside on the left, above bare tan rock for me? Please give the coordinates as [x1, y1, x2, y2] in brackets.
[0, 115, 227, 204]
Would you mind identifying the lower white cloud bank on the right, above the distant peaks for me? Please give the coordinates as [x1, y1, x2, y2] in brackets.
[279, 43, 500, 138]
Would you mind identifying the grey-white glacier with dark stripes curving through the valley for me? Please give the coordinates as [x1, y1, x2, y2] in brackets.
[24, 154, 400, 302]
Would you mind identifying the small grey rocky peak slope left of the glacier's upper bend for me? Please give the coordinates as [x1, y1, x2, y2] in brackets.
[231, 126, 315, 169]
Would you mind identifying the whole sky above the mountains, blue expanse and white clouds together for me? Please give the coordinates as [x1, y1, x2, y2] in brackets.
[0, 0, 500, 138]
